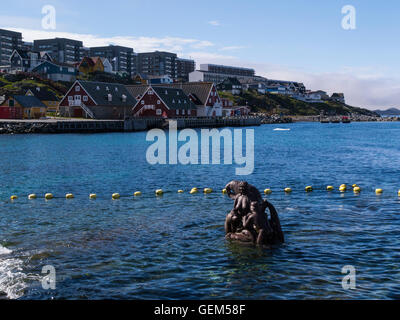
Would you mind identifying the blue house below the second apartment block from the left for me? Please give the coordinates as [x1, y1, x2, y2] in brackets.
[32, 61, 77, 82]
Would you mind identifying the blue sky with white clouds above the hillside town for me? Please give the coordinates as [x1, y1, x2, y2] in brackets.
[0, 0, 400, 109]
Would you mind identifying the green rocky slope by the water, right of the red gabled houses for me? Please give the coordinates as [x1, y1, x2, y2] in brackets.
[219, 91, 377, 116]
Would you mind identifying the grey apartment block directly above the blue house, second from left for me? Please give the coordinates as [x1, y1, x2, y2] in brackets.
[33, 38, 85, 63]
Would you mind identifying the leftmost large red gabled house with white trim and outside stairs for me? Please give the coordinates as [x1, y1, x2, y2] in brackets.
[59, 80, 137, 120]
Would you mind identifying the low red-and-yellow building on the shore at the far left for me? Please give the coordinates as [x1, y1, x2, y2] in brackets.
[0, 95, 47, 119]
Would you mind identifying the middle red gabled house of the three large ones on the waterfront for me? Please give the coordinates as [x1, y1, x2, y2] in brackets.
[132, 86, 197, 119]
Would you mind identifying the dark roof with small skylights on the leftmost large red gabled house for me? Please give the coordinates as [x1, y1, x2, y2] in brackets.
[78, 80, 137, 106]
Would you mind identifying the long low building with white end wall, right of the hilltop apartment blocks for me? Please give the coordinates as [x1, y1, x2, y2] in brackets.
[189, 64, 261, 84]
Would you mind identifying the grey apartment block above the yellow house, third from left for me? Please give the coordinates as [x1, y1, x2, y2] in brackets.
[90, 45, 137, 75]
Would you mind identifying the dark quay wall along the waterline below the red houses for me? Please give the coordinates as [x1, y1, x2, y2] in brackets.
[0, 117, 261, 134]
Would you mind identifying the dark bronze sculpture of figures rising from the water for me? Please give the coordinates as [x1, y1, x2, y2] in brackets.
[225, 181, 285, 246]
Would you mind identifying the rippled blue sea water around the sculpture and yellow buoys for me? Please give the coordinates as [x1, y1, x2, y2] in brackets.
[0, 123, 400, 300]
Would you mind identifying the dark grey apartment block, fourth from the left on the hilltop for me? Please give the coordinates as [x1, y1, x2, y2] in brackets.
[137, 51, 178, 79]
